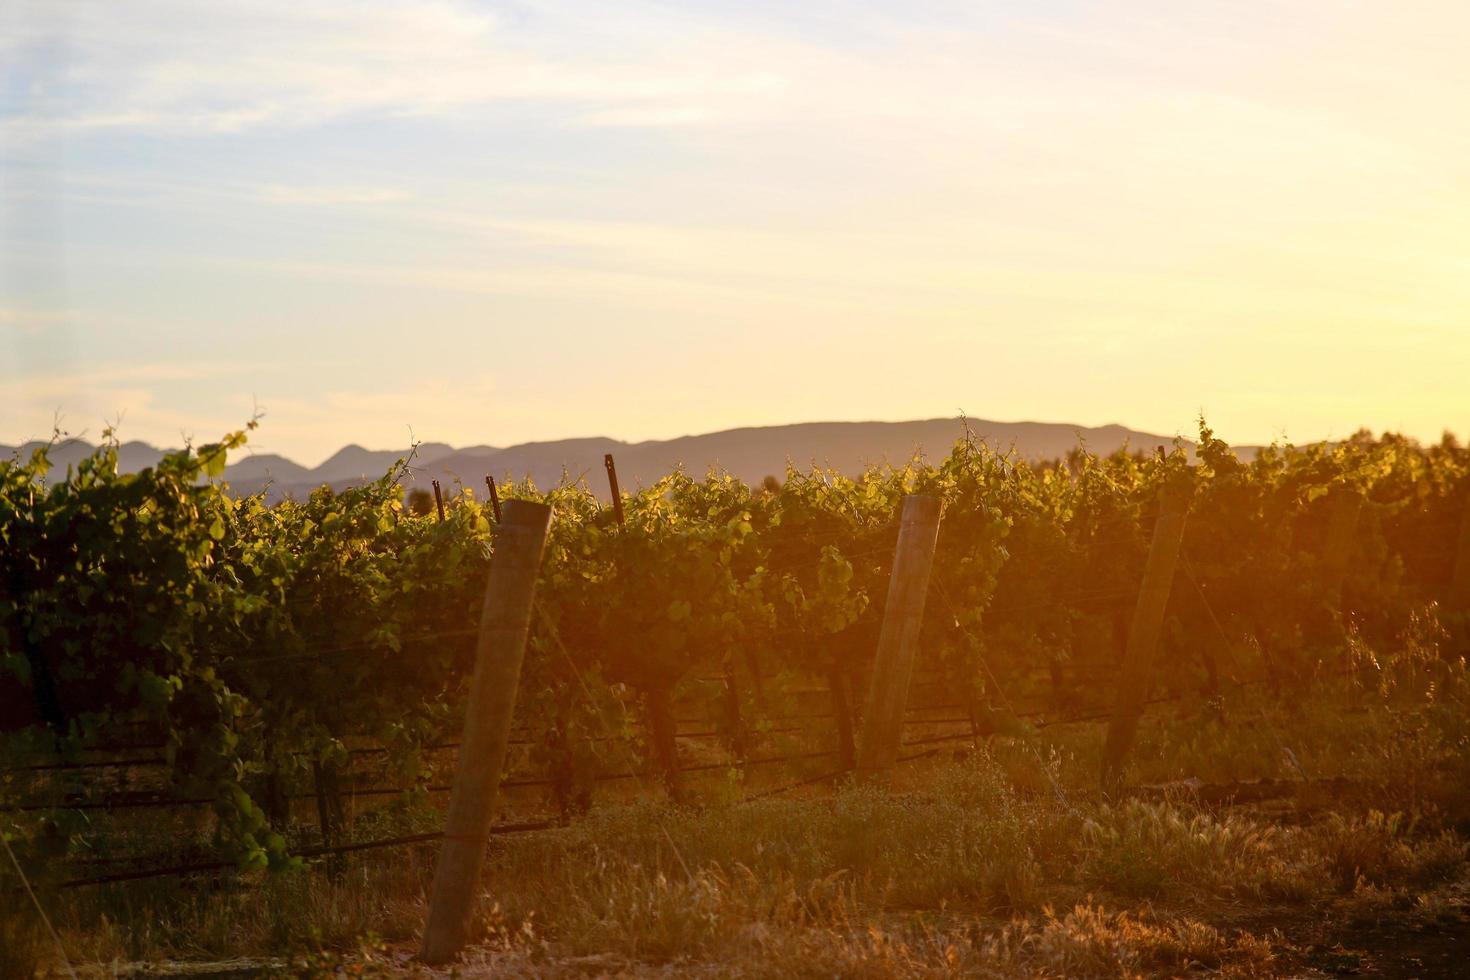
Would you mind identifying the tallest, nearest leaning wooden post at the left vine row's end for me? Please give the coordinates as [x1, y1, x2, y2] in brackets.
[420, 500, 551, 964]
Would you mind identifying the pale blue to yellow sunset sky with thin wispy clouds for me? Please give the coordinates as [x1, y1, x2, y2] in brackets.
[0, 0, 1470, 464]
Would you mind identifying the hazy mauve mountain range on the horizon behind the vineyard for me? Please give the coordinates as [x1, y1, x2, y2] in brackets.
[0, 419, 1192, 498]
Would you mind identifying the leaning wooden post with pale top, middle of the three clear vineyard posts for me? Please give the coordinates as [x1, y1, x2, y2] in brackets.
[857, 494, 939, 780]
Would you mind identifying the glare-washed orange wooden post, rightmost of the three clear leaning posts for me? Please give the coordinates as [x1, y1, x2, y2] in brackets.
[1103, 488, 1189, 792]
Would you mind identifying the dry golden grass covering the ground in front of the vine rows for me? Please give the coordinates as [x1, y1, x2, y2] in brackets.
[11, 640, 1470, 977]
